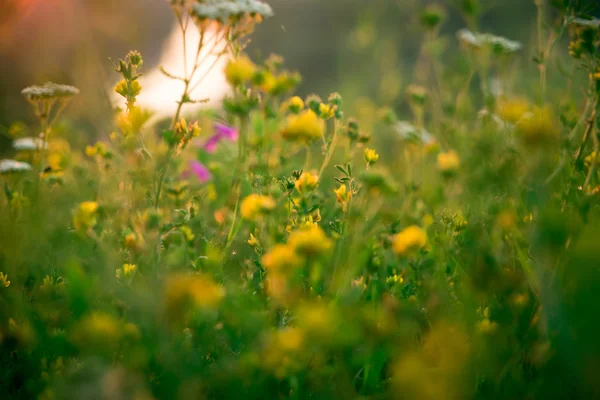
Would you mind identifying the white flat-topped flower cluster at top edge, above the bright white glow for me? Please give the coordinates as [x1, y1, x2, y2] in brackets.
[194, 0, 273, 21]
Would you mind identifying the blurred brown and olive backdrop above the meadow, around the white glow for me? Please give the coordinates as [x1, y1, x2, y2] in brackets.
[0, 0, 597, 151]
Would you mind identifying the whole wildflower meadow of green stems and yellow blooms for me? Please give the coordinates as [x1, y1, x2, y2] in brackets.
[0, 0, 600, 399]
